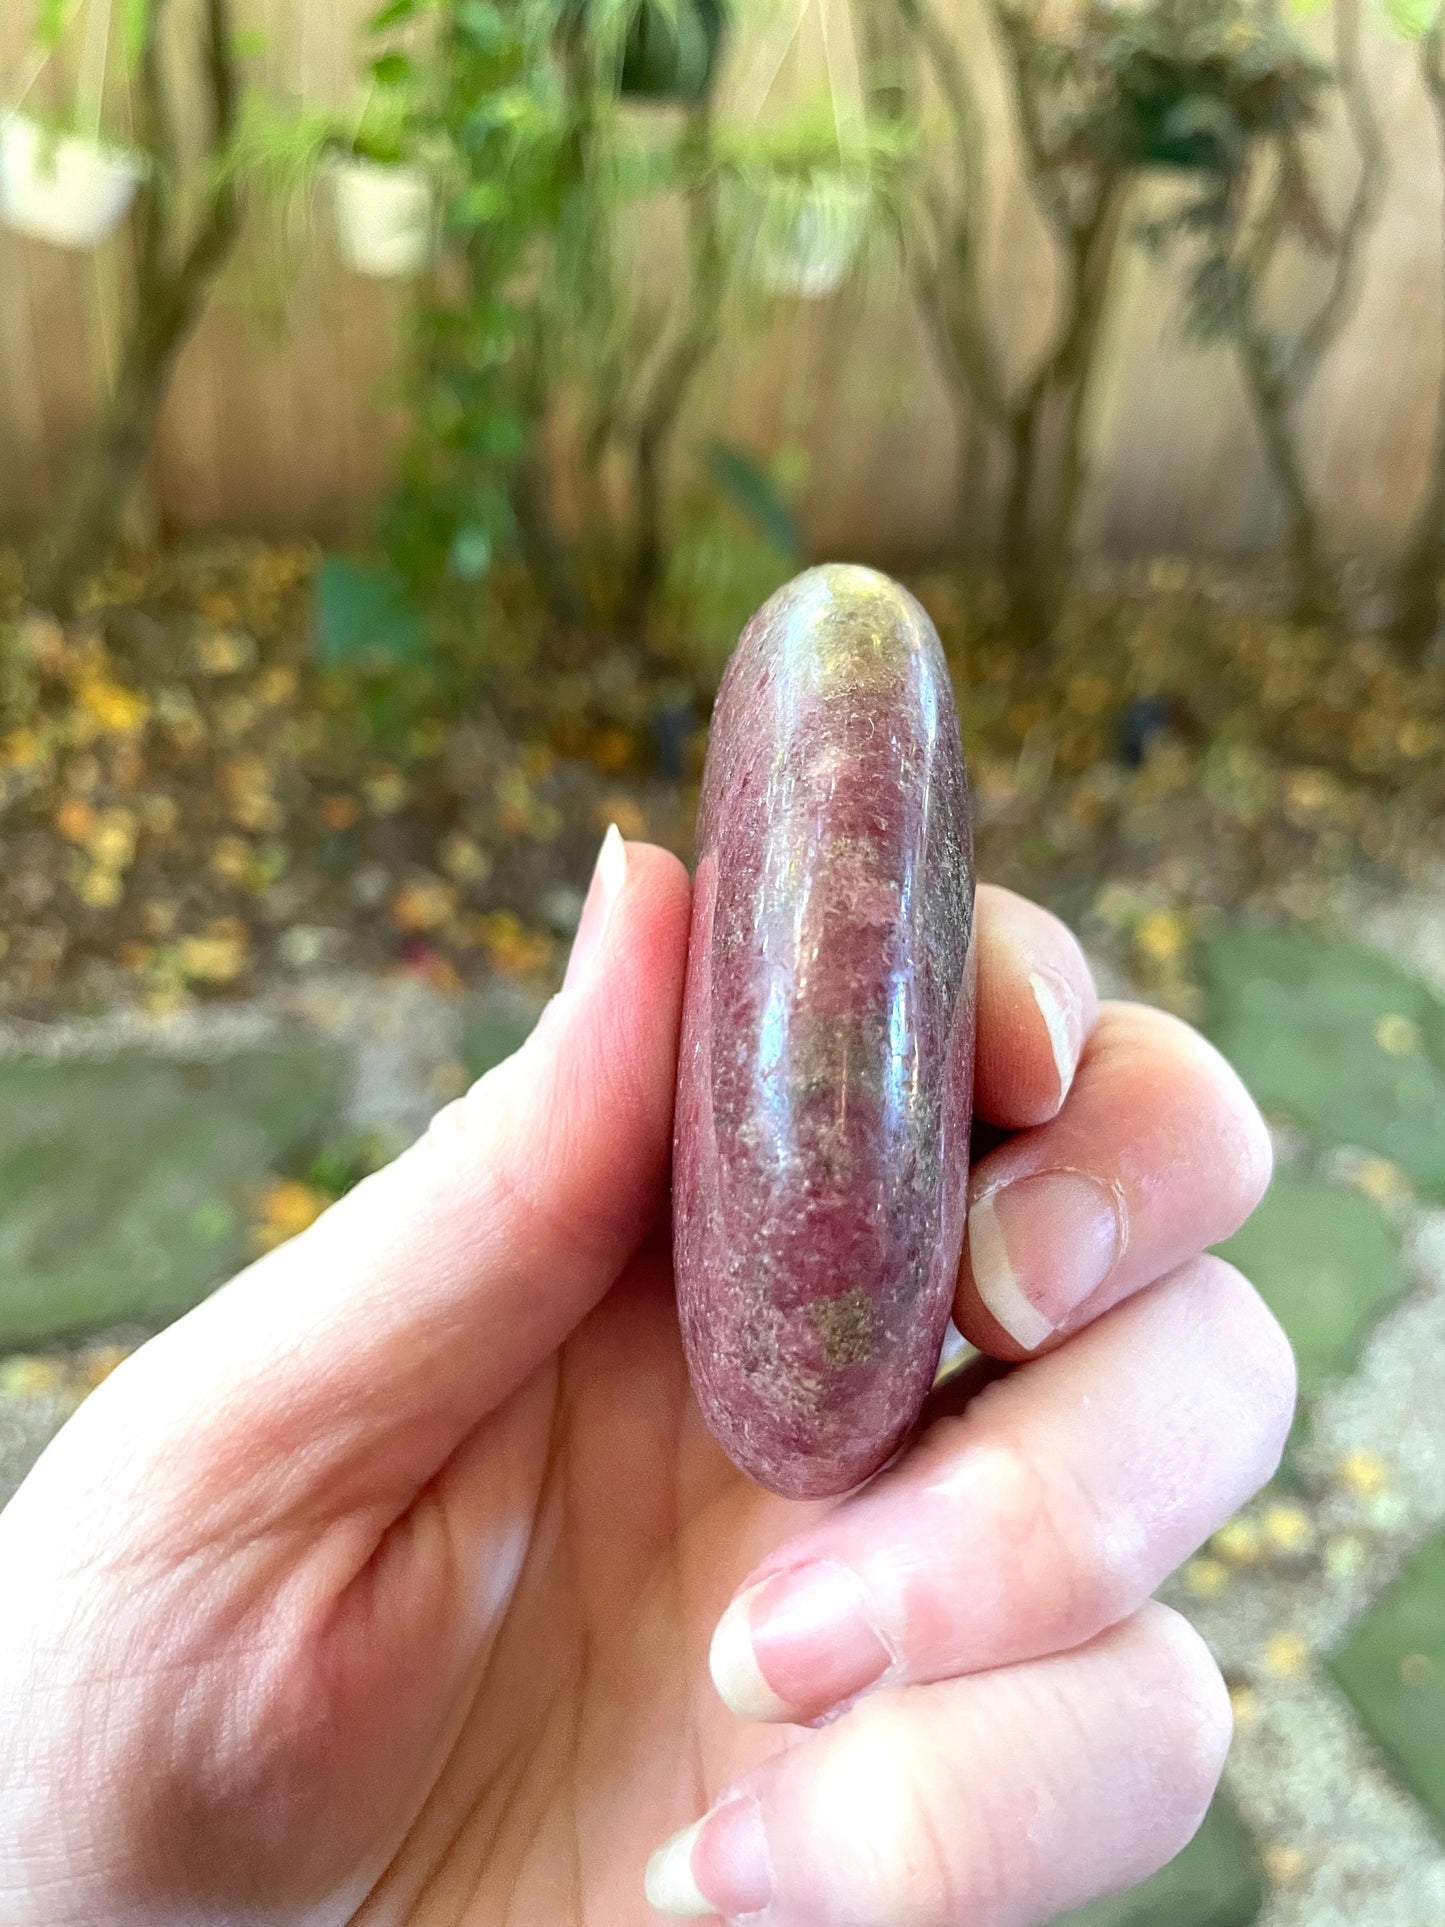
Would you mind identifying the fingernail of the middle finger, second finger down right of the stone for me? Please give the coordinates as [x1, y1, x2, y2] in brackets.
[969, 1172, 1125, 1351]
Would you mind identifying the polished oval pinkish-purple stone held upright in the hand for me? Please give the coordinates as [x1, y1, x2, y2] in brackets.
[672, 567, 973, 1497]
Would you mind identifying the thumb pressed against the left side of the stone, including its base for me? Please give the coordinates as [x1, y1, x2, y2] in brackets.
[67, 831, 688, 1526]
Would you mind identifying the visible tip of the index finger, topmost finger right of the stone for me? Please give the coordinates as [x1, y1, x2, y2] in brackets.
[973, 883, 1098, 1131]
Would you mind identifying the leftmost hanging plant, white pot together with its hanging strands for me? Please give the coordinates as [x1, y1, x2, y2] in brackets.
[0, 0, 150, 249]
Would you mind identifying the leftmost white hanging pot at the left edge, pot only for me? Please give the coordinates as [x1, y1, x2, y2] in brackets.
[0, 114, 150, 249]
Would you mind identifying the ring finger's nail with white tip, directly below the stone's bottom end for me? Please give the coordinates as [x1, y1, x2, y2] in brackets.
[707, 1559, 894, 1721]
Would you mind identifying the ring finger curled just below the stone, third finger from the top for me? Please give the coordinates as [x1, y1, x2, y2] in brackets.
[711, 1258, 1295, 1721]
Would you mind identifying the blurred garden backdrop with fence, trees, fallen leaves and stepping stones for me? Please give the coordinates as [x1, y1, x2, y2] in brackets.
[0, 0, 1445, 1927]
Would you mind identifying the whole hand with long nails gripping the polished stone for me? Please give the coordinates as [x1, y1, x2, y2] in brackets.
[0, 838, 1293, 1927]
